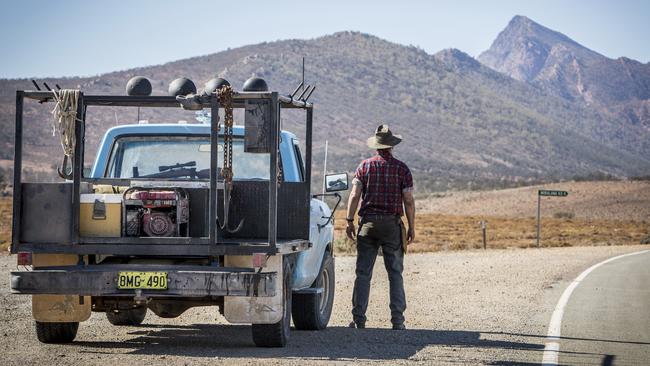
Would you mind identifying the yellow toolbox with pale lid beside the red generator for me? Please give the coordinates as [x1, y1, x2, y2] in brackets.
[79, 194, 122, 237]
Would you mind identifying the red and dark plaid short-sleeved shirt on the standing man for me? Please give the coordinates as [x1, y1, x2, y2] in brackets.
[354, 150, 413, 216]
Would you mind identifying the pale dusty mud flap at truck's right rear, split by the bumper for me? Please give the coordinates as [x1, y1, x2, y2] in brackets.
[223, 255, 284, 324]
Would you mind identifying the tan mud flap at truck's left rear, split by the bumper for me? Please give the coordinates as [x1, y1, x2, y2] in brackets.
[32, 253, 91, 323]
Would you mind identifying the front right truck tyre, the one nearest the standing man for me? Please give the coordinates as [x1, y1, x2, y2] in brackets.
[292, 251, 335, 330]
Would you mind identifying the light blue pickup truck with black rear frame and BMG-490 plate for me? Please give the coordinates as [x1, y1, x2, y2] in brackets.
[11, 78, 347, 347]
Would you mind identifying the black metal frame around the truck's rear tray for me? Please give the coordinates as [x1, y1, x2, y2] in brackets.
[11, 90, 313, 256]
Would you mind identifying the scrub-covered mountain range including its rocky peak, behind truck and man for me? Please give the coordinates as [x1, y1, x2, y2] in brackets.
[0, 16, 650, 191]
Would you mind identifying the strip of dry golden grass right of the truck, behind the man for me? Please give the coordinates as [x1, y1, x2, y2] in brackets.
[335, 212, 650, 253]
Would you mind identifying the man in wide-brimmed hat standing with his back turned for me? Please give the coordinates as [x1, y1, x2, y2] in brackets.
[346, 124, 415, 330]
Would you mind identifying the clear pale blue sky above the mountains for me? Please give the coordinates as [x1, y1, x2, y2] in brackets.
[0, 0, 650, 78]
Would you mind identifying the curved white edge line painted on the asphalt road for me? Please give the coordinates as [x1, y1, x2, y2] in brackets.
[542, 250, 650, 366]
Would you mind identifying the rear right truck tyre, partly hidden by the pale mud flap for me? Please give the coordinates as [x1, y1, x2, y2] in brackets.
[252, 256, 291, 347]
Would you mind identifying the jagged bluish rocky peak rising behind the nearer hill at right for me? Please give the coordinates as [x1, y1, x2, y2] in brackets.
[478, 16, 650, 132]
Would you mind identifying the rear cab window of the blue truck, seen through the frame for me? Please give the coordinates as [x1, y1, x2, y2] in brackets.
[105, 135, 269, 179]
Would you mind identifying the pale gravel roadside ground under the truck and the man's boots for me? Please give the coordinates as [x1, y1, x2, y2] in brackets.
[0, 246, 648, 365]
